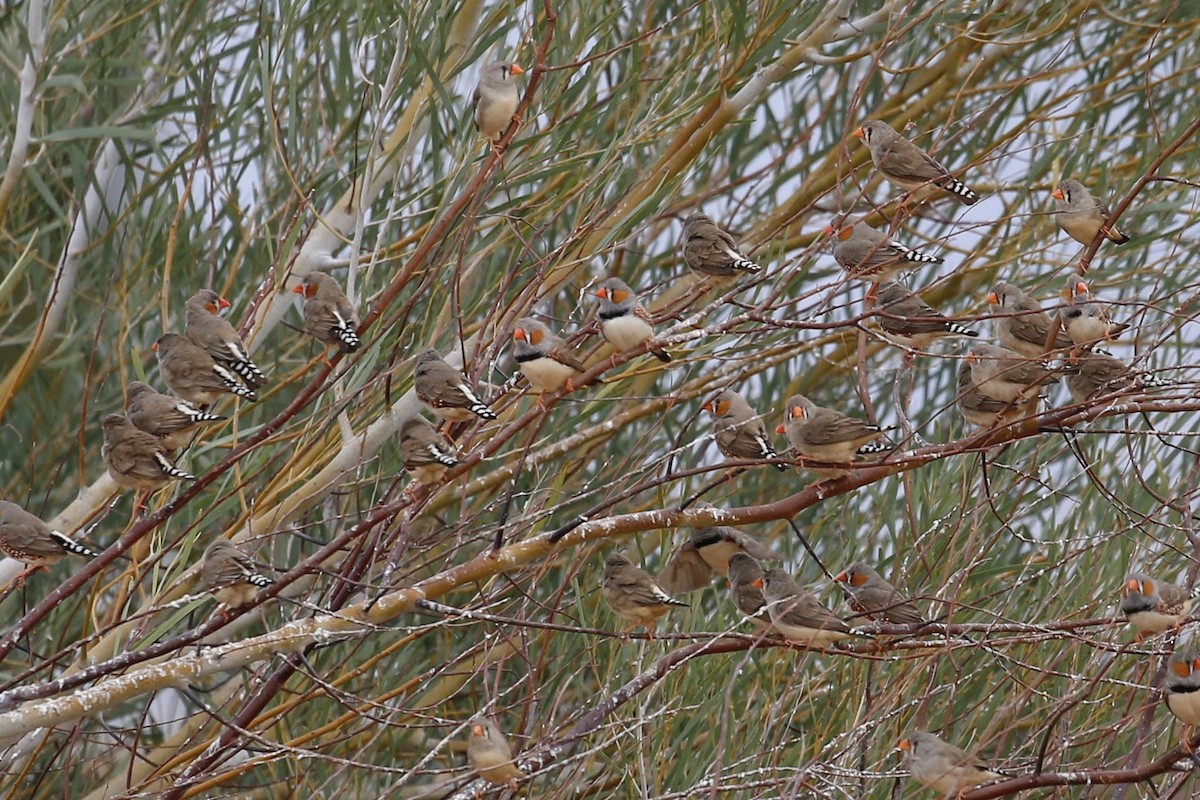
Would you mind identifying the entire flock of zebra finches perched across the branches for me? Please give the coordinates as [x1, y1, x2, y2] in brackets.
[0, 64, 1200, 795]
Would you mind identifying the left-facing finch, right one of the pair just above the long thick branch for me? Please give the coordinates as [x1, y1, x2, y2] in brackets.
[775, 395, 887, 477]
